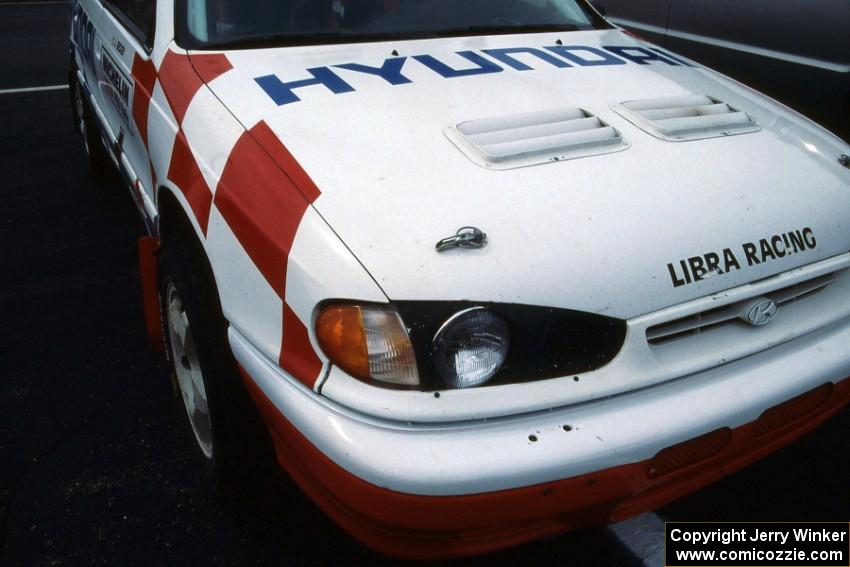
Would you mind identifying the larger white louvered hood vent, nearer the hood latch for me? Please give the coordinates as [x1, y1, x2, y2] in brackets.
[446, 108, 628, 169]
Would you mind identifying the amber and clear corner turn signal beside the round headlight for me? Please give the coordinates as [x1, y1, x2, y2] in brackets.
[316, 305, 419, 386]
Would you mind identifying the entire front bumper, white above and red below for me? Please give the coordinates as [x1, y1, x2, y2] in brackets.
[230, 322, 850, 558]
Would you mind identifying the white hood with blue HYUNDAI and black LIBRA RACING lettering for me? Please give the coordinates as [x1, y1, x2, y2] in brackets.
[195, 30, 850, 318]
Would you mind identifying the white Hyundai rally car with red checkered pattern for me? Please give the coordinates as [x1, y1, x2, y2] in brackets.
[71, 0, 850, 558]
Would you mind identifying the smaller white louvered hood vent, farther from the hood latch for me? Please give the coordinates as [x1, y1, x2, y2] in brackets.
[613, 95, 760, 142]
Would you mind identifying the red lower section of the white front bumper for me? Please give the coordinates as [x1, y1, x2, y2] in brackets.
[243, 372, 850, 559]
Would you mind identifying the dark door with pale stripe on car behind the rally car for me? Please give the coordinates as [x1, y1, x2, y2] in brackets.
[667, 0, 850, 135]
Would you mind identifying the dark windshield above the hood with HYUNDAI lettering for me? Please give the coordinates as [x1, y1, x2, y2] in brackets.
[179, 0, 607, 47]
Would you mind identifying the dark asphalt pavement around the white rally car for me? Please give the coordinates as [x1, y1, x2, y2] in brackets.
[0, 2, 850, 566]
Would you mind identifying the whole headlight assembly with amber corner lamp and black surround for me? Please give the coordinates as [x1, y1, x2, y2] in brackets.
[315, 300, 626, 392]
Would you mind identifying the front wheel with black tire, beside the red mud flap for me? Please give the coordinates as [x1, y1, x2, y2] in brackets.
[158, 226, 279, 503]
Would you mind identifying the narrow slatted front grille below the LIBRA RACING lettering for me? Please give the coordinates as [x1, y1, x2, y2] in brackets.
[646, 272, 837, 346]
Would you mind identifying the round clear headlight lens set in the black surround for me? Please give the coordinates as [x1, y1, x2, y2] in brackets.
[433, 307, 510, 388]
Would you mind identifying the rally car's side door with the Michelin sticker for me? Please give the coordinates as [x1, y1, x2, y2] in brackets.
[94, 0, 156, 229]
